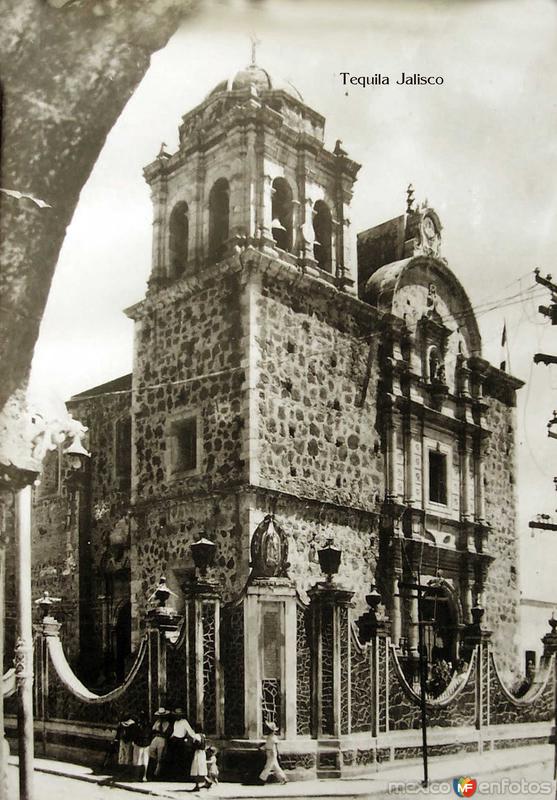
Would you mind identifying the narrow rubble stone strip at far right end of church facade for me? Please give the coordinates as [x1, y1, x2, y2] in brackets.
[484, 396, 520, 677]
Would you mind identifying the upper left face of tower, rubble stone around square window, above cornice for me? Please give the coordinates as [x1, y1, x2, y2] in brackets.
[133, 271, 243, 502]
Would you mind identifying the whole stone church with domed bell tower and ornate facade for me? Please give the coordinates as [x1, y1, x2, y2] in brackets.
[33, 63, 521, 738]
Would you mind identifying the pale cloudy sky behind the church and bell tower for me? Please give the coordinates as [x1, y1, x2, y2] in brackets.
[31, 0, 557, 602]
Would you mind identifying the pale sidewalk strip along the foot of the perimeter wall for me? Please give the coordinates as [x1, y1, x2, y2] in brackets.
[10, 745, 554, 800]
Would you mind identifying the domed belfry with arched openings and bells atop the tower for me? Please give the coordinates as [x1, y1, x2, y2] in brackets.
[144, 58, 359, 291]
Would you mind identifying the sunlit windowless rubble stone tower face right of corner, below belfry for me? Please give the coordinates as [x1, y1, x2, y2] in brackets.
[257, 268, 384, 509]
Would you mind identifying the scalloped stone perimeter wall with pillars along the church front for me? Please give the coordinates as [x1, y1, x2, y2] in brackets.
[10, 604, 555, 778]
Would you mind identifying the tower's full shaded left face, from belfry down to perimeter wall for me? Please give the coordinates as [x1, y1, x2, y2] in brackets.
[128, 263, 249, 641]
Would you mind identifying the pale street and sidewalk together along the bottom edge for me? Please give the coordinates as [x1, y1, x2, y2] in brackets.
[5, 745, 555, 800]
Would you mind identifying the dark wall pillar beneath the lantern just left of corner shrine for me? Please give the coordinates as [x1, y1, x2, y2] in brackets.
[180, 579, 219, 736]
